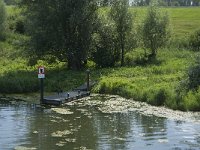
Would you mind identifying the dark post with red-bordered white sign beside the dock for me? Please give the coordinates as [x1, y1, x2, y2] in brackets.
[38, 66, 45, 104]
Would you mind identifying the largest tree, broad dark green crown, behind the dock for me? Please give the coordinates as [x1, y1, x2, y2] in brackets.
[22, 0, 97, 69]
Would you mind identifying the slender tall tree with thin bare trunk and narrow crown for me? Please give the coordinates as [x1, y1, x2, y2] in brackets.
[110, 0, 133, 66]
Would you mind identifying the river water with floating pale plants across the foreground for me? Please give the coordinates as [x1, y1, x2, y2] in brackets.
[0, 96, 200, 150]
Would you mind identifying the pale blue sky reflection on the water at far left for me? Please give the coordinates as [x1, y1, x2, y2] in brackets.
[0, 104, 27, 150]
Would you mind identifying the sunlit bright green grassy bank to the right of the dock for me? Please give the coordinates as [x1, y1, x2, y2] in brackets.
[94, 49, 197, 110]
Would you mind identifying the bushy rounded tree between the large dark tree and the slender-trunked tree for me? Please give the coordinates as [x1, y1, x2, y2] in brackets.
[92, 15, 120, 67]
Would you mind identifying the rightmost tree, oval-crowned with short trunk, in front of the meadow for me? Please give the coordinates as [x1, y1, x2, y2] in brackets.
[142, 1, 169, 59]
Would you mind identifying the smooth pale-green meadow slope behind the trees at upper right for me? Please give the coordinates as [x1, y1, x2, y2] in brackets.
[131, 7, 200, 38]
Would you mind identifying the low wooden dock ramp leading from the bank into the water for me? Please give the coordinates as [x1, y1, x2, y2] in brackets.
[42, 83, 94, 105]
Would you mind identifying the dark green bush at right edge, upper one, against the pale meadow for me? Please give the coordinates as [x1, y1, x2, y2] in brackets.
[189, 29, 200, 51]
